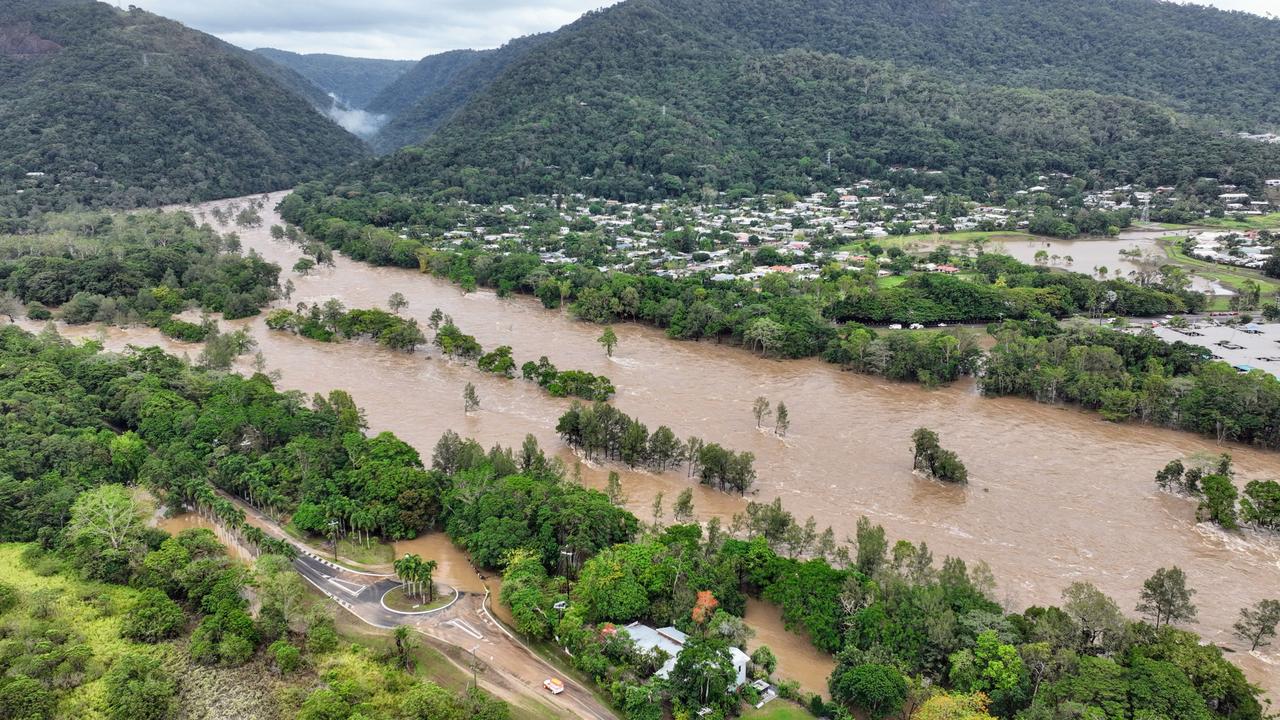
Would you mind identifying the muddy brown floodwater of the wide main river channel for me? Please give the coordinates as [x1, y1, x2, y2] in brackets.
[28, 195, 1280, 693]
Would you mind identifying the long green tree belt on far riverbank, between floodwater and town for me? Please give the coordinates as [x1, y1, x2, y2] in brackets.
[280, 187, 1204, 371]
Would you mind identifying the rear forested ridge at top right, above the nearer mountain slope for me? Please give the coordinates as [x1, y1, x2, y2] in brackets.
[665, 0, 1280, 127]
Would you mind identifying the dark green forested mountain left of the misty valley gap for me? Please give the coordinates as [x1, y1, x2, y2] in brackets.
[0, 0, 364, 215]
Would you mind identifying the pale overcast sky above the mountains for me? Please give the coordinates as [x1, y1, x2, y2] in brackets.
[117, 0, 1280, 60]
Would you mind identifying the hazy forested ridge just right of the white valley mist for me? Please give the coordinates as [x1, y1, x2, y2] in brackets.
[369, 35, 550, 152]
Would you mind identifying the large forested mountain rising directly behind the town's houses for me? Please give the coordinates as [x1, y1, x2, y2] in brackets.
[327, 0, 1280, 199]
